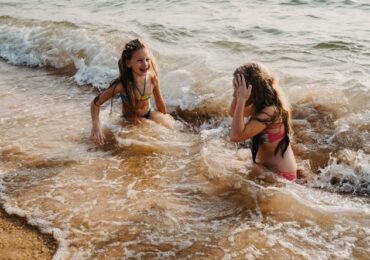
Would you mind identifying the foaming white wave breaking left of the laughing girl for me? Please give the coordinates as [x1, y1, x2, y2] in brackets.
[0, 16, 118, 87]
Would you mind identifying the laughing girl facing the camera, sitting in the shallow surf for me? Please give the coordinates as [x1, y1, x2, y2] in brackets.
[90, 39, 175, 144]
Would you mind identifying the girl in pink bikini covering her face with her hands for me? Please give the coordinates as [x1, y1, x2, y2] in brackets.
[230, 63, 297, 181]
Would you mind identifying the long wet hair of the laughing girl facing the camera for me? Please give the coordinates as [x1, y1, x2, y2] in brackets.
[105, 39, 158, 115]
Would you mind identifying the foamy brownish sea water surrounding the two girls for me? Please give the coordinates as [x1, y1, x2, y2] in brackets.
[0, 0, 370, 259]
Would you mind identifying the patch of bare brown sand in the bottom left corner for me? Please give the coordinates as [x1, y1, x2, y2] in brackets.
[0, 208, 57, 260]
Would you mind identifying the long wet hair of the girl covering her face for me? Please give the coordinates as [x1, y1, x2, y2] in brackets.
[234, 62, 292, 162]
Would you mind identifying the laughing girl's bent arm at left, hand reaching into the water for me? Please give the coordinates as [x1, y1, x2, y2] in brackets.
[90, 84, 123, 144]
